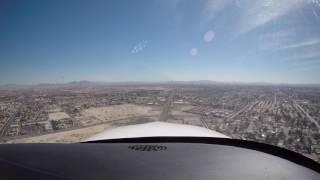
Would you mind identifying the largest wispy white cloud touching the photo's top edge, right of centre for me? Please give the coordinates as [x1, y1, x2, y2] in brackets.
[203, 0, 311, 34]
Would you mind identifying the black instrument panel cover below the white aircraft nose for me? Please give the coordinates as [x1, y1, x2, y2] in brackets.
[0, 137, 320, 180]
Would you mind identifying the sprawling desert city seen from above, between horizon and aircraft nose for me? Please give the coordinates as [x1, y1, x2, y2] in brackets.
[0, 83, 320, 162]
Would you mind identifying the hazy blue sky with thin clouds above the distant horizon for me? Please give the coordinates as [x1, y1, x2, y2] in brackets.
[0, 0, 320, 85]
